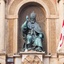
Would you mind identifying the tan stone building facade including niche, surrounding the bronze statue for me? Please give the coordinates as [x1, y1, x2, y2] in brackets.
[0, 0, 64, 64]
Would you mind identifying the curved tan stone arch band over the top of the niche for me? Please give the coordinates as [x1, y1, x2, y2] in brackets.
[8, 0, 56, 15]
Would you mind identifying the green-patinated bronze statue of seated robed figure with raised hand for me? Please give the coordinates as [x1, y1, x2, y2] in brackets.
[21, 12, 44, 52]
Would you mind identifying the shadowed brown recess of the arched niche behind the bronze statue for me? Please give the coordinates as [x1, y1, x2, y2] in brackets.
[17, 2, 47, 52]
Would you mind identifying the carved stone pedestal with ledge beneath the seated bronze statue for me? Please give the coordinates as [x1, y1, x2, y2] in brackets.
[20, 51, 45, 64]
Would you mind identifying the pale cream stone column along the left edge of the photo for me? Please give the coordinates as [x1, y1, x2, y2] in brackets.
[0, 0, 5, 52]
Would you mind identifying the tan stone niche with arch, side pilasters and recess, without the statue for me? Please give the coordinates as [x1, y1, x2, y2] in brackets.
[5, 0, 57, 55]
